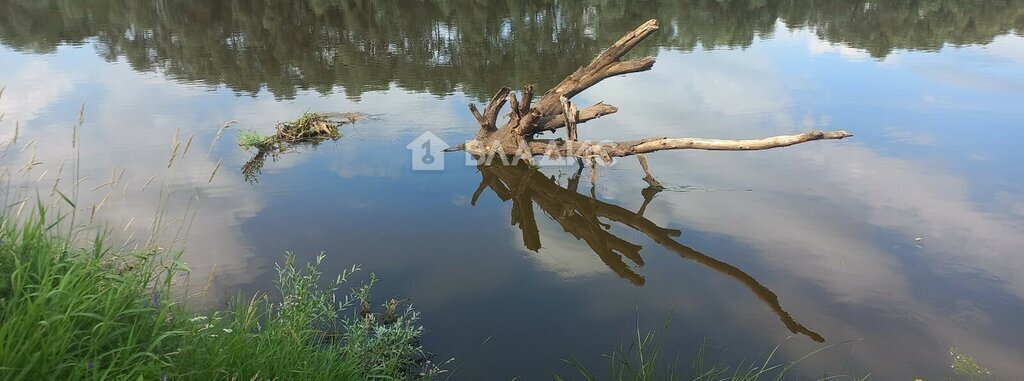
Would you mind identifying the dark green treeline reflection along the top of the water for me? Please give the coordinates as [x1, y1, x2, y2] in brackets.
[0, 0, 1024, 98]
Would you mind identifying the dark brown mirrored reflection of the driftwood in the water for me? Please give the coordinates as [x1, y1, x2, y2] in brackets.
[472, 163, 824, 342]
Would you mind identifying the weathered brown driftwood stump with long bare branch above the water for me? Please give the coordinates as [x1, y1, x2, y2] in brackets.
[459, 19, 853, 164]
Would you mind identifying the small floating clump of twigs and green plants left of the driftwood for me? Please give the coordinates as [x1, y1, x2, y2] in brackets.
[239, 113, 367, 182]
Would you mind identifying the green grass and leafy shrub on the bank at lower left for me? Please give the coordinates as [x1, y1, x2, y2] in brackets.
[0, 205, 439, 380]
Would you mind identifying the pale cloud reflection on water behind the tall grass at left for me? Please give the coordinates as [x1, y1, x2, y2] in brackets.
[0, 48, 270, 297]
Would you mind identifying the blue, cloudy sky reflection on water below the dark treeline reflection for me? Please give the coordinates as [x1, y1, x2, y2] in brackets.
[0, 2, 1024, 379]
